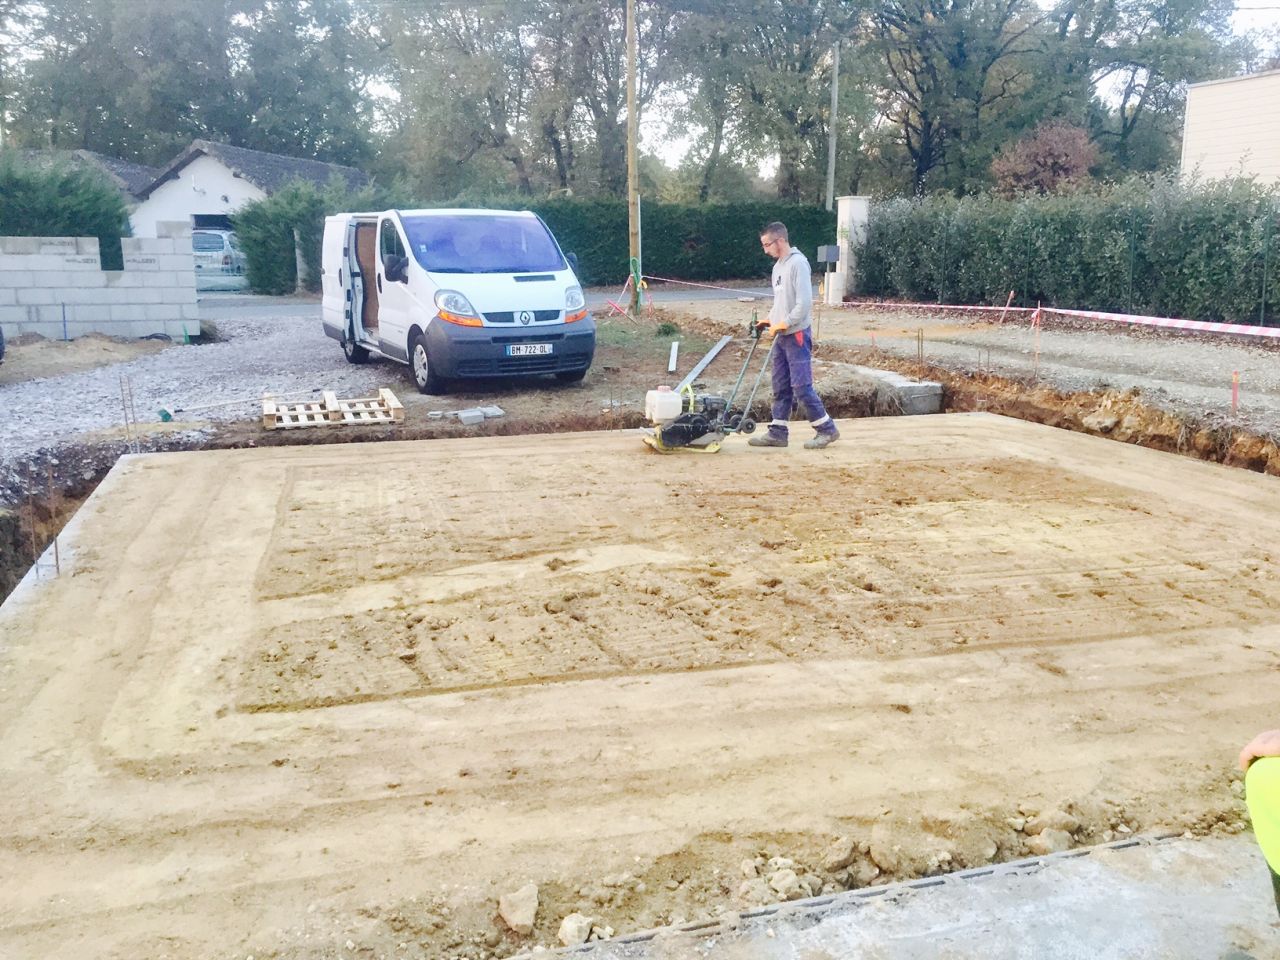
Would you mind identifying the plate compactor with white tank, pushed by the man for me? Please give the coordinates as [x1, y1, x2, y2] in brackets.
[641, 317, 773, 453]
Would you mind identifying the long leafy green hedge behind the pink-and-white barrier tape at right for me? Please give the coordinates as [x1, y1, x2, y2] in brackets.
[858, 178, 1280, 324]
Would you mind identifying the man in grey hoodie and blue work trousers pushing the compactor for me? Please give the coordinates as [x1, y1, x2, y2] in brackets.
[748, 221, 840, 449]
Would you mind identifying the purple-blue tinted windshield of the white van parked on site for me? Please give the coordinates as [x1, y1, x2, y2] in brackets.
[403, 216, 564, 274]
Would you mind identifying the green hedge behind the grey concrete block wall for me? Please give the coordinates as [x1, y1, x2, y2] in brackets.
[0, 151, 129, 270]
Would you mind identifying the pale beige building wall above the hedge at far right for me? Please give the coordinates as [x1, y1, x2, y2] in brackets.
[1181, 70, 1280, 183]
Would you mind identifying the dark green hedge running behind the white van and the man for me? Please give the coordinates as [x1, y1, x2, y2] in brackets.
[234, 183, 836, 293]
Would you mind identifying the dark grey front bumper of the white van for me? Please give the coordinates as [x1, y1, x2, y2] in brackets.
[426, 314, 595, 379]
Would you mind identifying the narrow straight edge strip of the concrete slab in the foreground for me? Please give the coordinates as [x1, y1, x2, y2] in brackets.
[509, 833, 1181, 960]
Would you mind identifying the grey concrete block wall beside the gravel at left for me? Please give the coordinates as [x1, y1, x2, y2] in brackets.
[0, 228, 200, 340]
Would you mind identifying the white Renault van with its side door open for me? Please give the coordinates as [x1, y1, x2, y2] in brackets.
[321, 210, 595, 393]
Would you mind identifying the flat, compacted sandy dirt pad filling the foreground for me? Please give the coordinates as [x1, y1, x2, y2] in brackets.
[0, 413, 1280, 960]
